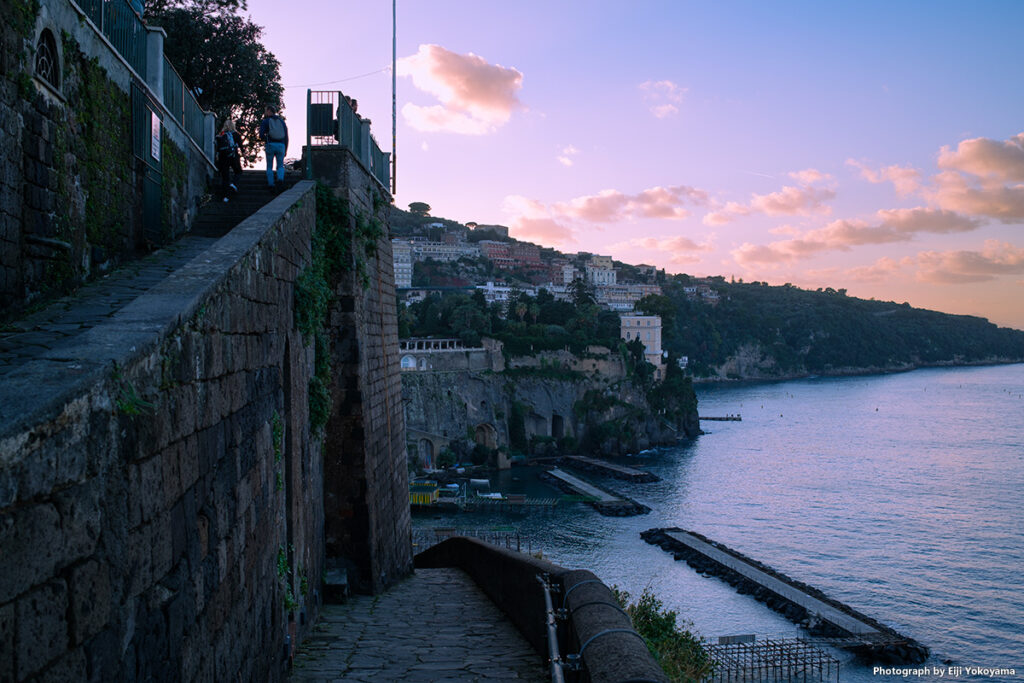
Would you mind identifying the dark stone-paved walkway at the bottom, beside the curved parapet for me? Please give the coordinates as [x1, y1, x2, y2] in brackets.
[290, 569, 551, 683]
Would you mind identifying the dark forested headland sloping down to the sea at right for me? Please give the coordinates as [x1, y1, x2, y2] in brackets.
[642, 275, 1024, 378]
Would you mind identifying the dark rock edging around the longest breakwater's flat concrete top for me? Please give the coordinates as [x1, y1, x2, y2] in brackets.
[640, 528, 929, 664]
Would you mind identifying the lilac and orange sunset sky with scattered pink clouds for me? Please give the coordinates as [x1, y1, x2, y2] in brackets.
[248, 0, 1024, 329]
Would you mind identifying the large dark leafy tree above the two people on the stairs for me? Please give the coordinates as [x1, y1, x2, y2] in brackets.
[146, 5, 285, 164]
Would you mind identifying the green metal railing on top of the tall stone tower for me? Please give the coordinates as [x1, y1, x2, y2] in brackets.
[306, 90, 391, 191]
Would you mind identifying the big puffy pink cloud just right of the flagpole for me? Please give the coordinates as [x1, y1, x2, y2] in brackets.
[398, 45, 522, 135]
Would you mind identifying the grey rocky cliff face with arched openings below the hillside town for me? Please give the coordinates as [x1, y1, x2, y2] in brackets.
[401, 371, 699, 466]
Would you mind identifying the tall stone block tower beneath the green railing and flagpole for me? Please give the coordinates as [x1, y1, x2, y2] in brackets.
[312, 148, 413, 592]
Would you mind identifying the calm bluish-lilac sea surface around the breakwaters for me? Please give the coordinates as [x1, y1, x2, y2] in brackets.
[414, 365, 1024, 681]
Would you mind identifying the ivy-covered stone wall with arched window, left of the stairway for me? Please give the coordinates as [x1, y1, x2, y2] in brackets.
[0, 0, 212, 321]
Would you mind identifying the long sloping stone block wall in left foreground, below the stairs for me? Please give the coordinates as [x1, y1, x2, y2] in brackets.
[0, 183, 323, 681]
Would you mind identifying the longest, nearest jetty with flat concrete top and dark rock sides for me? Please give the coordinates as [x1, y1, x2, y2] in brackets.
[640, 528, 929, 664]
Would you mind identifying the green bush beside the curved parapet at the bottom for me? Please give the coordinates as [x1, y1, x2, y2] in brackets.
[611, 587, 713, 682]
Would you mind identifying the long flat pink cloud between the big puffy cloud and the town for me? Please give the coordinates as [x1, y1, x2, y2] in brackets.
[555, 185, 708, 223]
